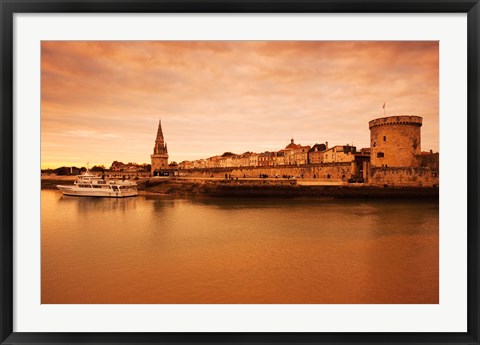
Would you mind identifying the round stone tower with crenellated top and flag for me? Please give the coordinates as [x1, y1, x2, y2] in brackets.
[368, 115, 422, 168]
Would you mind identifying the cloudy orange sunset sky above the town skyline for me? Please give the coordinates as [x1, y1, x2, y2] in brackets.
[41, 41, 439, 168]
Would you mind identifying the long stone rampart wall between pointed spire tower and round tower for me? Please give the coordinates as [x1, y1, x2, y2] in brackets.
[179, 163, 352, 180]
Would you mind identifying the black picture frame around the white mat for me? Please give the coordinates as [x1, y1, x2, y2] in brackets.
[0, 0, 480, 344]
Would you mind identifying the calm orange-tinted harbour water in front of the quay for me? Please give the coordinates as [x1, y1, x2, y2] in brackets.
[41, 190, 439, 304]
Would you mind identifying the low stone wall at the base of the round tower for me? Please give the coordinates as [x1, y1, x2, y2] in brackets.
[368, 167, 439, 187]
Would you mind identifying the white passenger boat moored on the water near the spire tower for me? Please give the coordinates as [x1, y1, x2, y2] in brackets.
[57, 170, 138, 198]
